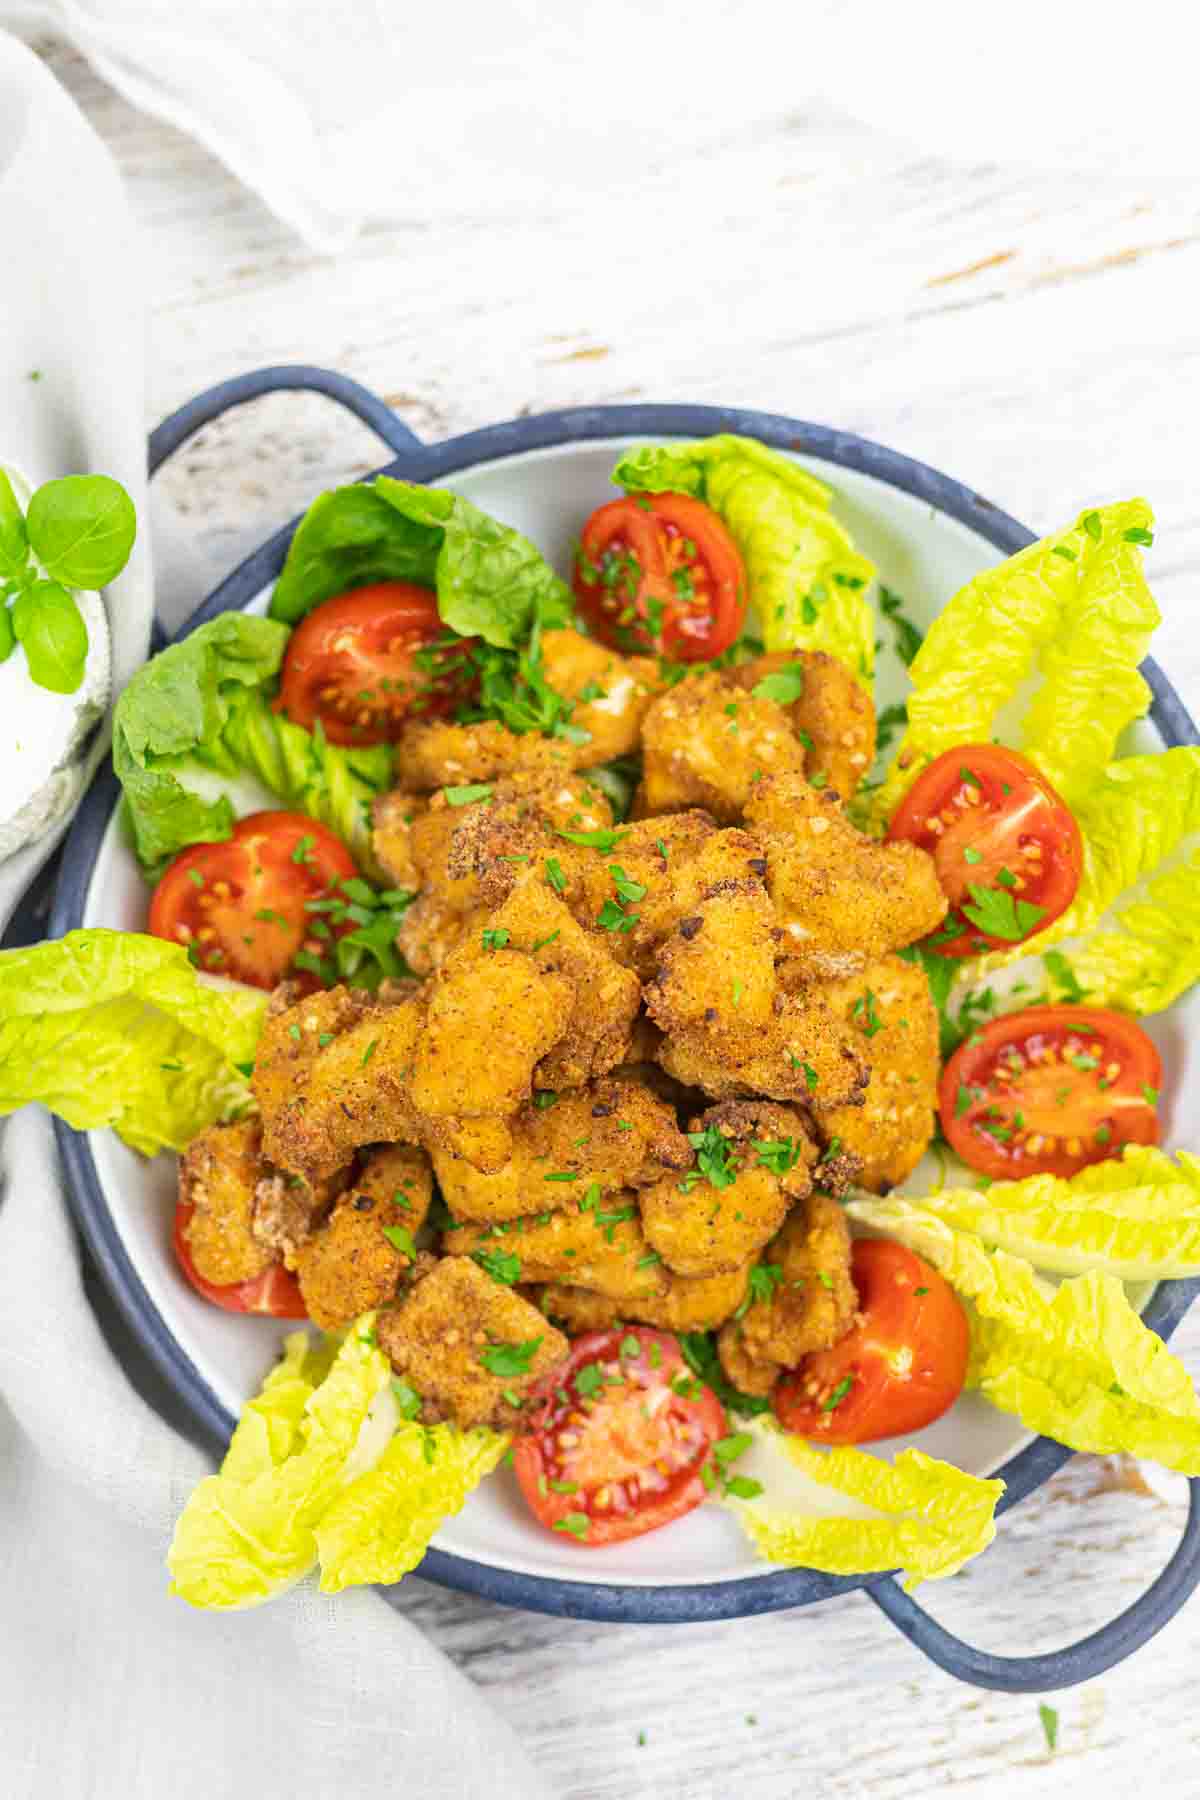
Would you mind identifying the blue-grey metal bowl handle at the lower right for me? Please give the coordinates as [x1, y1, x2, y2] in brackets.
[867, 1480, 1200, 1694]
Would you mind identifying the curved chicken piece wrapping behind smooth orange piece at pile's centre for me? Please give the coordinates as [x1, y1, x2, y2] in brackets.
[489, 871, 642, 1098]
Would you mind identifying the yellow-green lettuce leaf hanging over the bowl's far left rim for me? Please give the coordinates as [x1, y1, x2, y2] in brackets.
[0, 929, 266, 1156]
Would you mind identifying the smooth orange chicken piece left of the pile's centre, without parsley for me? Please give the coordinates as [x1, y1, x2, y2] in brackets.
[410, 943, 576, 1143]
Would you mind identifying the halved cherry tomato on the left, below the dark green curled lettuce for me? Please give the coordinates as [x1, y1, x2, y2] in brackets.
[149, 812, 358, 992]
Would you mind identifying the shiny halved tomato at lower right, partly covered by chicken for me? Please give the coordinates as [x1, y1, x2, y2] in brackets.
[772, 1238, 970, 1444]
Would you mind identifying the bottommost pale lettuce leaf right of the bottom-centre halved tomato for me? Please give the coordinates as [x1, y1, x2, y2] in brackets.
[725, 1420, 1004, 1593]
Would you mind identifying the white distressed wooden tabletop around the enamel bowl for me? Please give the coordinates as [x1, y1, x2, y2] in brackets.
[35, 31, 1200, 1800]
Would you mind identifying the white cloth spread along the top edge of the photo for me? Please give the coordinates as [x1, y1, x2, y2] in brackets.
[0, 0, 1200, 254]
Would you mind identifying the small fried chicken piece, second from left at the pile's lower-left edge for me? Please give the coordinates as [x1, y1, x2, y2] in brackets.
[295, 1143, 434, 1332]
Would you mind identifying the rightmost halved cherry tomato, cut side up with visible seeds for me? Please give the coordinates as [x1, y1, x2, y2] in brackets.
[939, 1006, 1162, 1181]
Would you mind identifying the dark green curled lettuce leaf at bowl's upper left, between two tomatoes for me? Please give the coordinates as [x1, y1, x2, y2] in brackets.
[113, 612, 392, 871]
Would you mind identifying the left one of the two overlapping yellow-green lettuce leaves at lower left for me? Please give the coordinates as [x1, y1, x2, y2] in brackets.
[167, 1316, 398, 1611]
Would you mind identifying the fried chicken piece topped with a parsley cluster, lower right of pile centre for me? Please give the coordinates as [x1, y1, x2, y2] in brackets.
[640, 1100, 817, 1274]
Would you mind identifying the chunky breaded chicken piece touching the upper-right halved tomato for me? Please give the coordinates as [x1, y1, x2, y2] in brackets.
[747, 776, 946, 979]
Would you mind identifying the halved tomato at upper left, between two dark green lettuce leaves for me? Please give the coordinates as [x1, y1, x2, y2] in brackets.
[275, 581, 475, 743]
